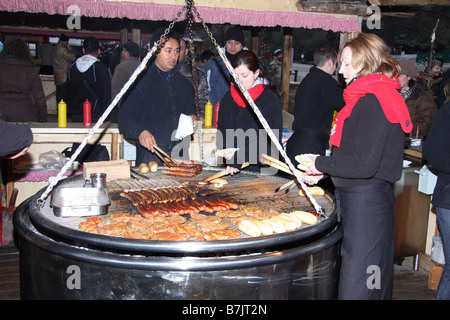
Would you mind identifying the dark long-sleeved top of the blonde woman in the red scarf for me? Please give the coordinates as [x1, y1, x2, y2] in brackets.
[315, 93, 405, 187]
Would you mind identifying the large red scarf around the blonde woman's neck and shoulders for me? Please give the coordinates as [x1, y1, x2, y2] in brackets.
[330, 73, 412, 148]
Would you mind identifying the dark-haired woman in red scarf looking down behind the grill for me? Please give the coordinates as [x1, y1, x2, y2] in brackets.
[216, 50, 283, 173]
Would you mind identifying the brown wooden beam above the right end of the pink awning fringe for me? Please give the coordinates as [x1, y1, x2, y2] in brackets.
[295, 0, 367, 15]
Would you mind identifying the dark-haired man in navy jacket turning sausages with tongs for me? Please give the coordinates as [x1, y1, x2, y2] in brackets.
[118, 30, 196, 165]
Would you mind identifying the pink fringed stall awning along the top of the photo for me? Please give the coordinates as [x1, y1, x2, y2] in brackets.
[0, 0, 360, 32]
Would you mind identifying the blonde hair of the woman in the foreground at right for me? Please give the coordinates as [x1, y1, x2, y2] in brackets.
[338, 33, 400, 79]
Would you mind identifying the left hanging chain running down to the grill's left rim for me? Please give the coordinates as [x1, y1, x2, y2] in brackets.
[37, 6, 187, 207]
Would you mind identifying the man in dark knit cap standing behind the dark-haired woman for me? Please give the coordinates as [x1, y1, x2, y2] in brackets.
[203, 27, 245, 106]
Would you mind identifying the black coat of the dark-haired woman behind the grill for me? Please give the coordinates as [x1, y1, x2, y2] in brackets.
[216, 87, 283, 170]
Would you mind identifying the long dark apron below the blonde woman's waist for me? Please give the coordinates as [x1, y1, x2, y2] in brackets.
[335, 182, 395, 300]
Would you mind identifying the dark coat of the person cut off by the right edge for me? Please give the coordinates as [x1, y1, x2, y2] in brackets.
[422, 101, 450, 209]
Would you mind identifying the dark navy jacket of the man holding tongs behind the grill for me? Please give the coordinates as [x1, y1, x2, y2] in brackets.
[118, 63, 195, 164]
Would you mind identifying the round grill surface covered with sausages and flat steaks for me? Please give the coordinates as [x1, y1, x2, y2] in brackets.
[38, 170, 333, 241]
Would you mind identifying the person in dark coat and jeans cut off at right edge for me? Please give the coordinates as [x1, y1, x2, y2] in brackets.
[422, 81, 450, 300]
